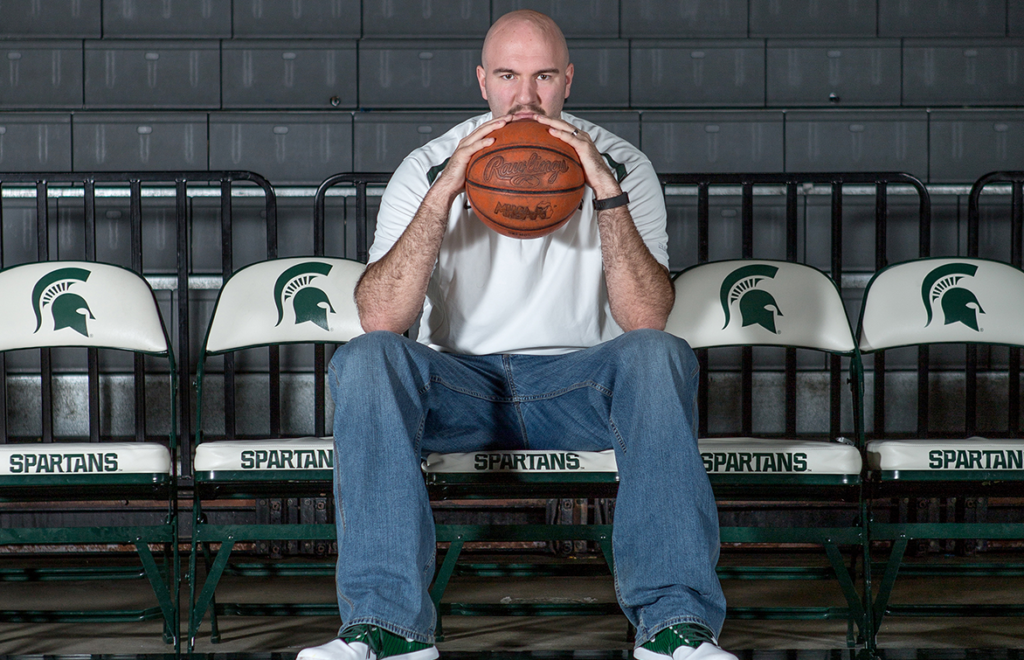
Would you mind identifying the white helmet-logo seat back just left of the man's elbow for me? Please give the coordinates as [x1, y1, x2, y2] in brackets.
[206, 257, 364, 353]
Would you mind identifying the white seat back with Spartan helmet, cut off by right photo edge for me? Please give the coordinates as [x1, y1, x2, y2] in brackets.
[858, 258, 1024, 352]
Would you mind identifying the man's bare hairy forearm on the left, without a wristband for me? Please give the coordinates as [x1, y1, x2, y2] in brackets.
[355, 181, 454, 333]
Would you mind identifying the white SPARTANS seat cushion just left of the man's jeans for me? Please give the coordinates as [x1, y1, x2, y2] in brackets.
[196, 438, 334, 472]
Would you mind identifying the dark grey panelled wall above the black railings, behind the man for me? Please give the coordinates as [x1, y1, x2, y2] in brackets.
[0, 0, 1024, 184]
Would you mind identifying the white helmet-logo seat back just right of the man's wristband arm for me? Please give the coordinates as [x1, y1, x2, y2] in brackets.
[666, 260, 855, 354]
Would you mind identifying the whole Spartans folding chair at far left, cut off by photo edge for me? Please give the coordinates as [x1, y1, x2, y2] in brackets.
[0, 261, 178, 645]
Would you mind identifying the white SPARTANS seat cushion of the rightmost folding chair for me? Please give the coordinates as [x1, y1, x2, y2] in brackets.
[867, 437, 1024, 472]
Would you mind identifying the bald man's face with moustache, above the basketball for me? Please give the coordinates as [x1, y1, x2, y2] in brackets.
[476, 23, 572, 118]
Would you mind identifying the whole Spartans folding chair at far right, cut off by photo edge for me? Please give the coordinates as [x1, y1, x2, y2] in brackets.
[858, 258, 1024, 629]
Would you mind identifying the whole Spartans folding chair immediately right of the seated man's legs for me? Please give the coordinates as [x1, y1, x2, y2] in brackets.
[666, 259, 870, 647]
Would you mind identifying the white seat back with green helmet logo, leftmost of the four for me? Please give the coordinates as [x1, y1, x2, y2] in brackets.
[0, 261, 168, 354]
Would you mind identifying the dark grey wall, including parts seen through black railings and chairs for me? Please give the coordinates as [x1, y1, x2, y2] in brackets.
[0, 0, 1024, 452]
